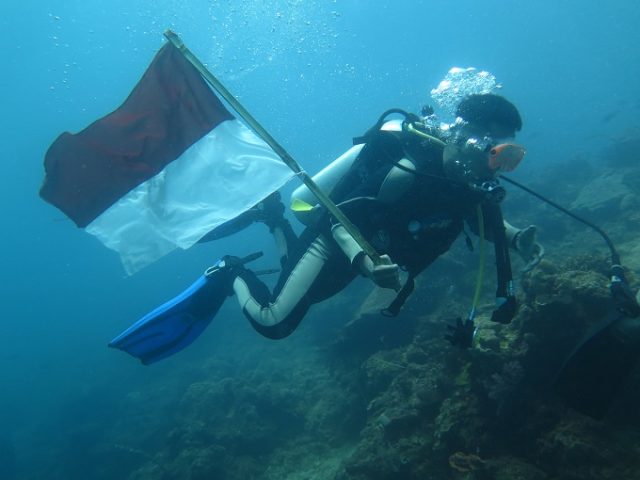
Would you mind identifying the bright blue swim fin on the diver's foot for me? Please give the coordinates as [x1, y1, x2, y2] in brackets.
[109, 252, 262, 365]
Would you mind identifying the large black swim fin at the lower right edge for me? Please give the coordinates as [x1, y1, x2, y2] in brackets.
[554, 311, 640, 420]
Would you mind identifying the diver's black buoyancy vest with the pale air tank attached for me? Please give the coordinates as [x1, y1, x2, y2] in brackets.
[292, 110, 511, 315]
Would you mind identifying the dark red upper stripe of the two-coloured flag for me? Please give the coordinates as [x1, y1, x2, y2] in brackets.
[40, 43, 233, 227]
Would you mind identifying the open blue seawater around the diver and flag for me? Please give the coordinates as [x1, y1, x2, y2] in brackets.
[0, 0, 640, 480]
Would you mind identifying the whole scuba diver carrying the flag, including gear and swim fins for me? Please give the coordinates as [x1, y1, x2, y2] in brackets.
[110, 93, 544, 363]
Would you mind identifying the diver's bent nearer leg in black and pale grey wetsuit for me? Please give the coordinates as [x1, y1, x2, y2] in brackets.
[233, 235, 356, 339]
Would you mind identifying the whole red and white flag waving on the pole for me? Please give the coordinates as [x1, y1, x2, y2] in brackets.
[40, 43, 293, 274]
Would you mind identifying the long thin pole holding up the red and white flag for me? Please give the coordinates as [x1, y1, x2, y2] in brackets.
[164, 29, 380, 264]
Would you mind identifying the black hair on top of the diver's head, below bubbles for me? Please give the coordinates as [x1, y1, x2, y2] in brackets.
[456, 93, 522, 134]
